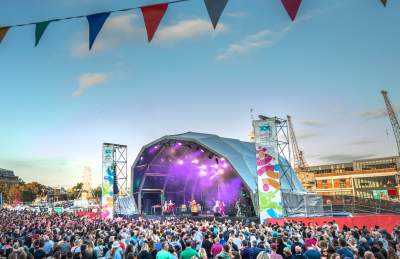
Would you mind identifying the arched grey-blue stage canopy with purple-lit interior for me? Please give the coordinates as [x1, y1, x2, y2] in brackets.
[131, 132, 322, 215]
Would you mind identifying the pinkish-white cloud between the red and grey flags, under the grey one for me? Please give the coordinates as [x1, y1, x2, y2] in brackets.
[154, 19, 227, 42]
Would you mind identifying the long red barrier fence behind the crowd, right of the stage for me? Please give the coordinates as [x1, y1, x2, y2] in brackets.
[268, 215, 400, 231]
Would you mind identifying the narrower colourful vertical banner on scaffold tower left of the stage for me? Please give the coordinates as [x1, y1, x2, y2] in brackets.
[101, 144, 115, 219]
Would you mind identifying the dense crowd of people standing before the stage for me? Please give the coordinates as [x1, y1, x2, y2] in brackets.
[0, 210, 400, 259]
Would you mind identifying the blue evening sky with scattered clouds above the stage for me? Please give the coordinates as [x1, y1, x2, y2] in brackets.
[0, 0, 400, 186]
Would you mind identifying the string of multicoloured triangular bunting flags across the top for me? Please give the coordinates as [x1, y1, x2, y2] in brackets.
[0, 0, 389, 47]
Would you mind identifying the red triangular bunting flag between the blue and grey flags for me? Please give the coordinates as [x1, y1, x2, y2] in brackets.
[140, 3, 168, 42]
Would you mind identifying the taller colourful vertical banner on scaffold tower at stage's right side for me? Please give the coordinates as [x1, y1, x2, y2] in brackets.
[253, 118, 283, 222]
